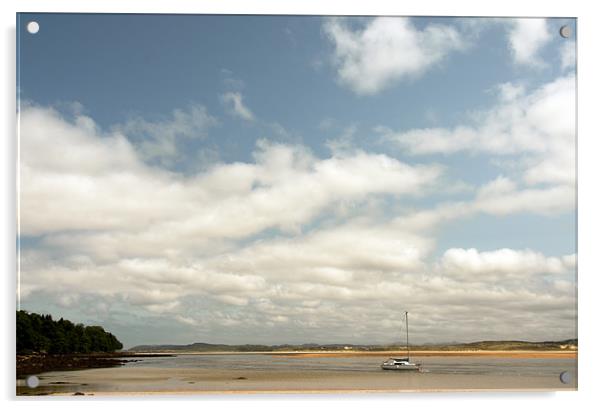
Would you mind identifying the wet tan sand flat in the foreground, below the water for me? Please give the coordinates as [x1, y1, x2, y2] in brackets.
[17, 367, 576, 396]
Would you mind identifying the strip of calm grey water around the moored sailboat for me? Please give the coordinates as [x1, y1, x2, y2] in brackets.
[120, 354, 576, 377]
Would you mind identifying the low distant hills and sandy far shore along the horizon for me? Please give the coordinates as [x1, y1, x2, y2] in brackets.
[129, 339, 577, 352]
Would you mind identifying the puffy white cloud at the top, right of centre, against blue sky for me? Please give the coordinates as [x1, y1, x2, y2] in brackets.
[323, 17, 465, 95]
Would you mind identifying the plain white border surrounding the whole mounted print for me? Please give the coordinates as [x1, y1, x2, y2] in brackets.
[0, 0, 602, 409]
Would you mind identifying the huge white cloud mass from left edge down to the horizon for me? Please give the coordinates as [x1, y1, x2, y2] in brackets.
[20, 106, 576, 343]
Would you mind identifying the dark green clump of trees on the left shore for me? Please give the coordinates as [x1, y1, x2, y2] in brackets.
[17, 311, 123, 354]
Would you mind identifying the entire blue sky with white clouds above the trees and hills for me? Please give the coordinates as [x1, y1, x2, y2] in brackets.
[17, 13, 577, 347]
